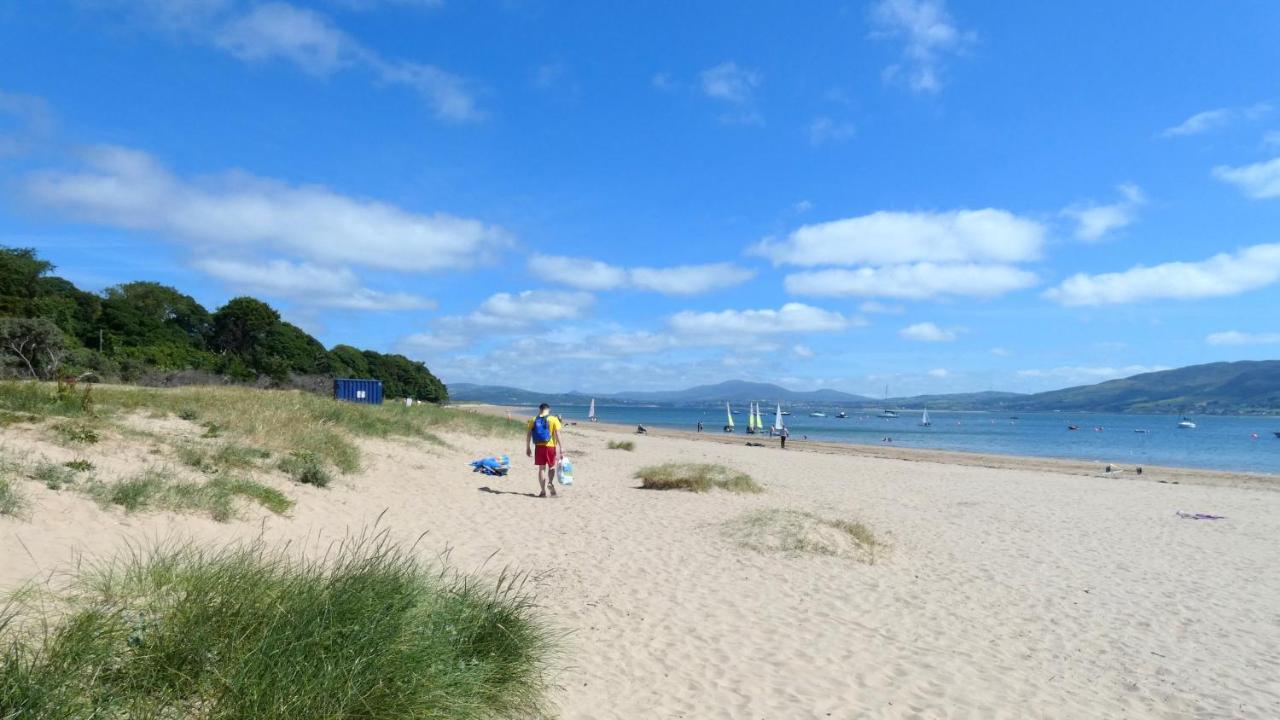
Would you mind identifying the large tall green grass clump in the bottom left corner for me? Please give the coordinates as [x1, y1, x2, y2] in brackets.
[0, 534, 553, 720]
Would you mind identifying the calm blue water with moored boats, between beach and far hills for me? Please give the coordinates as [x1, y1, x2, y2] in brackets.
[519, 402, 1280, 474]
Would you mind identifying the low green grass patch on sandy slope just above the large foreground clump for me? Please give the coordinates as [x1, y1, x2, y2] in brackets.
[87, 468, 293, 520]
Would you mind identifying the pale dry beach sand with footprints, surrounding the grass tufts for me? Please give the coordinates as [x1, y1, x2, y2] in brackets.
[0, 417, 1280, 719]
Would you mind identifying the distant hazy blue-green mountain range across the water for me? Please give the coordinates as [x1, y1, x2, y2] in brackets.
[449, 360, 1280, 414]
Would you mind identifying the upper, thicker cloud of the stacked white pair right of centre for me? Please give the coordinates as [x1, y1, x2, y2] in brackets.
[751, 208, 1044, 266]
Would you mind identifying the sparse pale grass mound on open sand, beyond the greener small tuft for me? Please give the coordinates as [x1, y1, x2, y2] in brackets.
[723, 509, 884, 564]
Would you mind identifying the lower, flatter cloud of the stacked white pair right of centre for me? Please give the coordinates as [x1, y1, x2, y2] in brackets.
[783, 263, 1038, 300]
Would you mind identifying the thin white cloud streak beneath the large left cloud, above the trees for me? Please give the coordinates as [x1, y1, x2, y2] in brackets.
[195, 258, 435, 310]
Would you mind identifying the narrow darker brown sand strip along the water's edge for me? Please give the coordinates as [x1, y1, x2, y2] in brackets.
[452, 402, 1280, 491]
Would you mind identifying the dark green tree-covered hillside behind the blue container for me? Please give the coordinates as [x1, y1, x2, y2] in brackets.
[0, 246, 448, 402]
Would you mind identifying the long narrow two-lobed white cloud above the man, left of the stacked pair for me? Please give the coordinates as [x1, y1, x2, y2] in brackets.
[529, 255, 755, 295]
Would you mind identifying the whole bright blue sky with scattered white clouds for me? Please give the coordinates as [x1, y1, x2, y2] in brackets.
[0, 0, 1280, 396]
